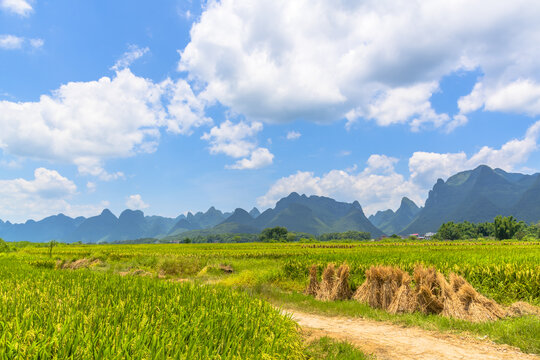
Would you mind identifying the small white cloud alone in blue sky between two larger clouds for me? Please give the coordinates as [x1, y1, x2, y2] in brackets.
[201, 120, 274, 169]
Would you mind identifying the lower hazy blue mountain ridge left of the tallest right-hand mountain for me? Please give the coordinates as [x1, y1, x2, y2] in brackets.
[0, 193, 383, 243]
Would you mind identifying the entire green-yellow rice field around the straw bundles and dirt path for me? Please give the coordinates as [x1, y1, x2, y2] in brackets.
[0, 241, 540, 359]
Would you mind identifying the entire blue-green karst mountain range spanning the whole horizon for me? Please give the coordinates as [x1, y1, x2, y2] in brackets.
[4, 166, 540, 243]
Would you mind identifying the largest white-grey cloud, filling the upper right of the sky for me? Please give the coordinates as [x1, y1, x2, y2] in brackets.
[179, 0, 540, 130]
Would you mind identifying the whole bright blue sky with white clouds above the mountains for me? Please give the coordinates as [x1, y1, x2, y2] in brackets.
[0, 0, 540, 222]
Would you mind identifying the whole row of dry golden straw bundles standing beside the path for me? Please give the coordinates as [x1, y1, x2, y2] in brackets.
[306, 264, 540, 322]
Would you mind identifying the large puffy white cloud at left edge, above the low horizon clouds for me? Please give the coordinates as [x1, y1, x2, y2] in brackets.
[0, 69, 209, 180]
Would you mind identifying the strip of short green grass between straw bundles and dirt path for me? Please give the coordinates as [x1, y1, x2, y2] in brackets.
[254, 286, 540, 354]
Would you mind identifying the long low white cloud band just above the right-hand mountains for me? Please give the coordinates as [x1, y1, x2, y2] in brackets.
[257, 121, 540, 214]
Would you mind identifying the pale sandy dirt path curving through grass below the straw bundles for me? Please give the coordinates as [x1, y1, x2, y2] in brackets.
[286, 310, 540, 360]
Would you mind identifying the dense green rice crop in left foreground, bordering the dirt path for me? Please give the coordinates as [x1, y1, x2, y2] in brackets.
[0, 258, 302, 359]
